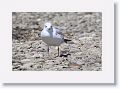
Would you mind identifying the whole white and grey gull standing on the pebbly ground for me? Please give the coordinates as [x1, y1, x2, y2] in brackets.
[41, 23, 70, 56]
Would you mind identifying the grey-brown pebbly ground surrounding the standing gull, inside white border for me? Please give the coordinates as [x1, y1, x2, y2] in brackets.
[12, 12, 102, 71]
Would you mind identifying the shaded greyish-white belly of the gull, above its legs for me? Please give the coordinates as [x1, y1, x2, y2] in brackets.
[42, 37, 63, 46]
